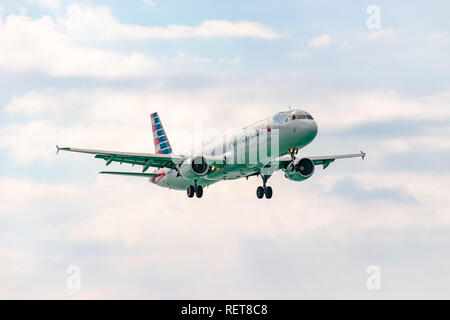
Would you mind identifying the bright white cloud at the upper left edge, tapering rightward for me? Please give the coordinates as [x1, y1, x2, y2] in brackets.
[0, 15, 155, 78]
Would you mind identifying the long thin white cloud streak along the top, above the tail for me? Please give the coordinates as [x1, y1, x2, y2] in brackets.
[58, 5, 281, 41]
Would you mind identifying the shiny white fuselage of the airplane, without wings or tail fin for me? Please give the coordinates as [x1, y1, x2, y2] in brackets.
[150, 110, 317, 190]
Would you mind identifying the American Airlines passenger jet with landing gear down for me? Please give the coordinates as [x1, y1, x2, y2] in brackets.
[56, 109, 366, 199]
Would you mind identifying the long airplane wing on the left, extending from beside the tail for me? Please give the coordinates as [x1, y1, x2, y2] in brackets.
[56, 146, 185, 172]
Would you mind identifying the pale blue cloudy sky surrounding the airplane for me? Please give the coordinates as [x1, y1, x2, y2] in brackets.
[0, 0, 450, 299]
